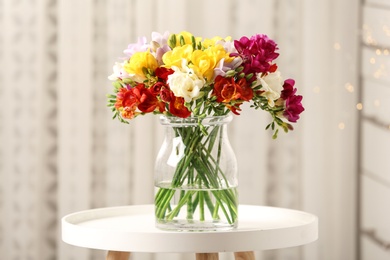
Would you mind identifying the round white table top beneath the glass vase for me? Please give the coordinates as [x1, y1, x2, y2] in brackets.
[62, 205, 318, 253]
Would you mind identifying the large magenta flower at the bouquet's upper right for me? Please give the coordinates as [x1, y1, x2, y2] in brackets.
[231, 34, 279, 77]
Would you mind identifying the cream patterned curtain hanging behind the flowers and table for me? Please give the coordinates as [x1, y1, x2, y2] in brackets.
[0, 0, 359, 260]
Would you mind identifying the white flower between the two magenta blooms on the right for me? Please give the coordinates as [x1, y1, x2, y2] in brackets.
[257, 71, 283, 107]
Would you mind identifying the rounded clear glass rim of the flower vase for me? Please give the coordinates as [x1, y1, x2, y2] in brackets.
[160, 114, 233, 126]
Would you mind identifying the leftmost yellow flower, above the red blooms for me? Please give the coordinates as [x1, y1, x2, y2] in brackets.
[124, 50, 158, 79]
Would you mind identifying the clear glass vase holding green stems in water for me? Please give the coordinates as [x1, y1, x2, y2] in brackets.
[154, 115, 238, 231]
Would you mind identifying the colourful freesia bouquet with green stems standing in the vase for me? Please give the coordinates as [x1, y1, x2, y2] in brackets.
[108, 32, 304, 230]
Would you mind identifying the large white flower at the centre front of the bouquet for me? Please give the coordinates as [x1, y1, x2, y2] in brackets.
[167, 60, 206, 102]
